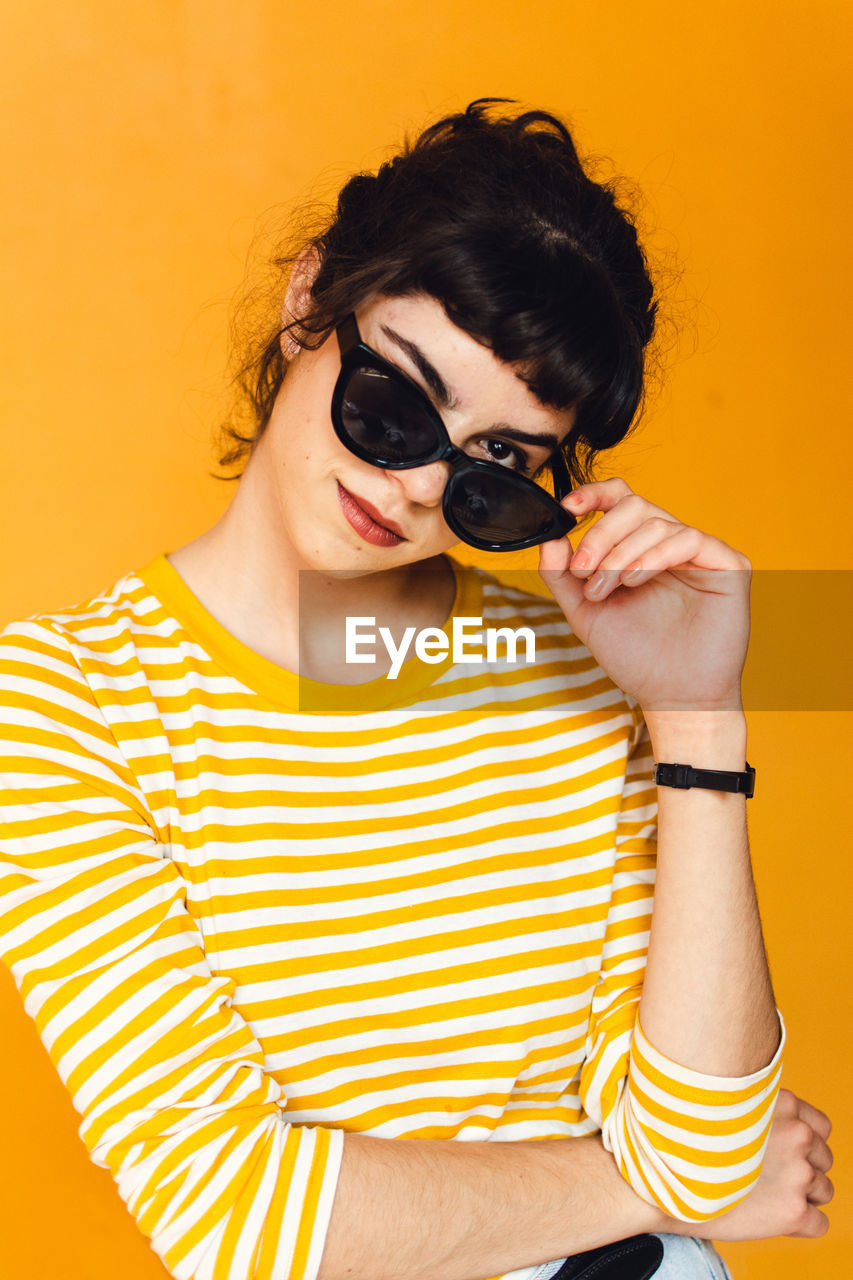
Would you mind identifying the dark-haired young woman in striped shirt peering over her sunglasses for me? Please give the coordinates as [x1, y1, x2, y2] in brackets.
[0, 102, 831, 1280]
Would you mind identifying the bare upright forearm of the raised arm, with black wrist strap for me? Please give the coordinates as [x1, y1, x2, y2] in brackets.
[639, 710, 779, 1076]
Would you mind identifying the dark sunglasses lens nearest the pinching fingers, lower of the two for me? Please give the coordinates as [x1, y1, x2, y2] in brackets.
[448, 468, 558, 545]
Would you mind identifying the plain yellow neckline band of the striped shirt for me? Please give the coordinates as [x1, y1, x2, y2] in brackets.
[137, 552, 483, 714]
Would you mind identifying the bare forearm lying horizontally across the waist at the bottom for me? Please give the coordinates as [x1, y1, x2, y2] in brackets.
[320, 1134, 670, 1280]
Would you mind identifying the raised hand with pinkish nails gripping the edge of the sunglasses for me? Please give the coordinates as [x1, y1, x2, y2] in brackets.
[539, 476, 752, 721]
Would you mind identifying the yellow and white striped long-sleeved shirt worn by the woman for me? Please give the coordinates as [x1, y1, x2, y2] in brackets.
[0, 556, 781, 1280]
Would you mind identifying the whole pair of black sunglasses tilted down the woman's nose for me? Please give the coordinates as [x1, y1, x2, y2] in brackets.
[332, 315, 576, 552]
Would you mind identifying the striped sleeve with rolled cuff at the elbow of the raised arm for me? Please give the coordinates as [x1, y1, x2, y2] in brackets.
[580, 709, 784, 1221]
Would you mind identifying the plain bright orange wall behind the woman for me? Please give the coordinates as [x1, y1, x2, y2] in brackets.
[0, 0, 853, 1280]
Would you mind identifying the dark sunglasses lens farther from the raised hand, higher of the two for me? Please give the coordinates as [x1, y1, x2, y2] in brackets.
[341, 369, 438, 463]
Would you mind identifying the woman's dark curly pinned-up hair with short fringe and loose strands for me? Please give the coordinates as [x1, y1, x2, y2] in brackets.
[213, 99, 657, 484]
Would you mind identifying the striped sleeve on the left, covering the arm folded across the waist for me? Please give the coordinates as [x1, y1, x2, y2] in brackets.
[0, 622, 342, 1280]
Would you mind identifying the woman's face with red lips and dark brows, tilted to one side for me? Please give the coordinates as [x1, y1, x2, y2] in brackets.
[262, 294, 573, 573]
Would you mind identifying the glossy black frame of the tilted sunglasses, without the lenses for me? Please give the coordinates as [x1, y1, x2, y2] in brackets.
[332, 312, 578, 552]
